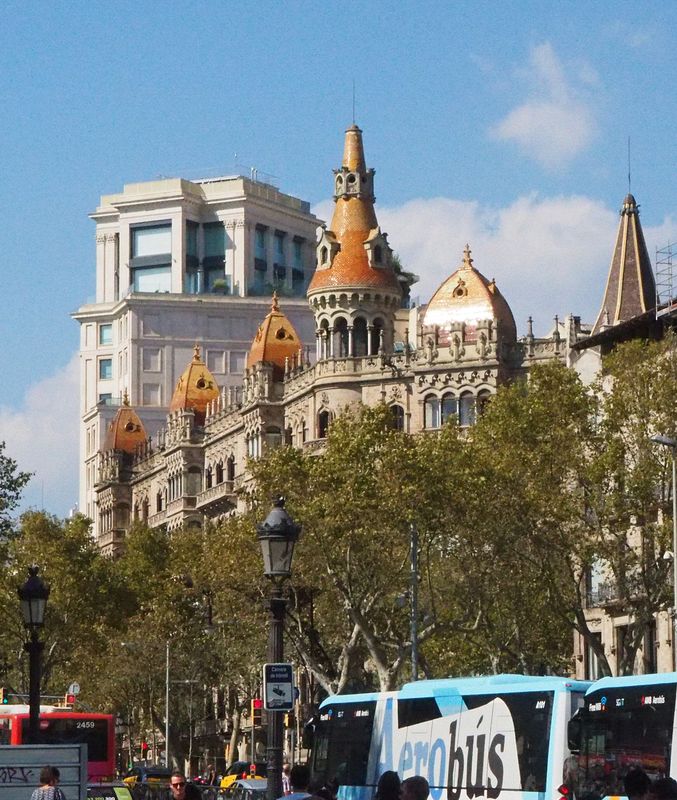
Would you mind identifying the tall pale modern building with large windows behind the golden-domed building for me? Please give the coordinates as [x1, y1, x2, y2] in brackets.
[73, 176, 321, 536]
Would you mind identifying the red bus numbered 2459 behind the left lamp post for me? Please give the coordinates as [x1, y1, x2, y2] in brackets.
[0, 705, 115, 781]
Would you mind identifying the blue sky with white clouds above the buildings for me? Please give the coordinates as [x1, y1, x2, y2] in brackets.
[0, 0, 677, 515]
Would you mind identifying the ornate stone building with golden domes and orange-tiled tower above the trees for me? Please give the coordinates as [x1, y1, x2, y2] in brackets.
[94, 125, 597, 555]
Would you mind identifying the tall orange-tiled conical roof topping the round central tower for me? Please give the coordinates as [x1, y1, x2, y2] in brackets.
[308, 125, 400, 294]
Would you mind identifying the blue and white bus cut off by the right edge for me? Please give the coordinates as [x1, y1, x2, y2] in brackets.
[567, 672, 677, 800]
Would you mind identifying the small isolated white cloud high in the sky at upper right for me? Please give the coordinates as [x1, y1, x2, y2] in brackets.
[490, 42, 597, 169]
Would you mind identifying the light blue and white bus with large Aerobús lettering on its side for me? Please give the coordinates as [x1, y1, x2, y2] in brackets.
[310, 675, 590, 800]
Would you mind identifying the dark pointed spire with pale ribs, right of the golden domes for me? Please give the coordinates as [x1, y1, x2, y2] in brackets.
[592, 194, 656, 336]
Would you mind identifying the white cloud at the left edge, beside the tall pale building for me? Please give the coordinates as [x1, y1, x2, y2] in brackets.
[0, 354, 80, 517]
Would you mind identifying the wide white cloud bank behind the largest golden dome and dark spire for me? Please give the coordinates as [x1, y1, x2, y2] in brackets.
[313, 194, 677, 335]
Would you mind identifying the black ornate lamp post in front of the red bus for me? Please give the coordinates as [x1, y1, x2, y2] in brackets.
[18, 564, 49, 744]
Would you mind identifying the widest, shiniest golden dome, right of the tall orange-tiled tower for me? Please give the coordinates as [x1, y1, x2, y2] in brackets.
[423, 245, 517, 339]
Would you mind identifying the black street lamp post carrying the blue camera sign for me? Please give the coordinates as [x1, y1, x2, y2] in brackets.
[252, 497, 301, 800]
